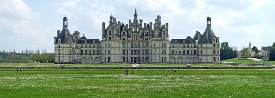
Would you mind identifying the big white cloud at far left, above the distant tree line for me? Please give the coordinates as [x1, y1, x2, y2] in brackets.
[0, 0, 50, 50]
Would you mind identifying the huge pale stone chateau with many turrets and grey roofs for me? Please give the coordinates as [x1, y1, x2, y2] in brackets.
[54, 10, 220, 64]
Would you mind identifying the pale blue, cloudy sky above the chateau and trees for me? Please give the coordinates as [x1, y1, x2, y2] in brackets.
[0, 0, 275, 52]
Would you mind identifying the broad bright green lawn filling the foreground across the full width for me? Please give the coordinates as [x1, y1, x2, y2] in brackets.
[0, 70, 275, 98]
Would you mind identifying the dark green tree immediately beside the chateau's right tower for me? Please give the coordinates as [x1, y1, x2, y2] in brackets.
[220, 42, 238, 60]
